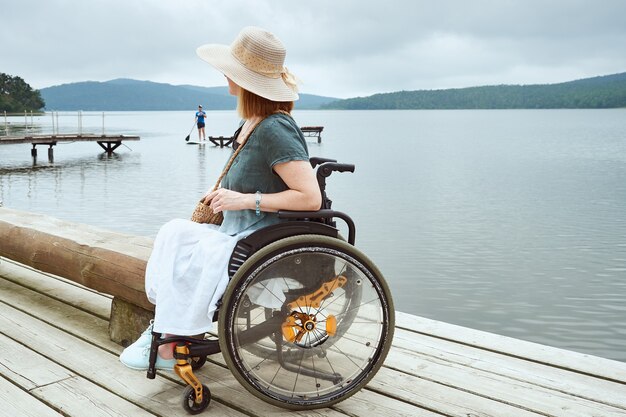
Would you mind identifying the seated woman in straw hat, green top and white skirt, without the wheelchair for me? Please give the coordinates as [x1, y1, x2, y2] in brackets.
[121, 28, 321, 369]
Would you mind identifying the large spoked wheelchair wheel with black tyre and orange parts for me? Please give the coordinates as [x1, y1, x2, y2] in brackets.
[219, 235, 394, 410]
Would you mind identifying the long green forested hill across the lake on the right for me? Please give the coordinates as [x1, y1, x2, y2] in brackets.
[323, 73, 626, 110]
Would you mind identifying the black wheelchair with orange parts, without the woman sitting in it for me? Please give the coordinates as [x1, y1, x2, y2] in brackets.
[147, 157, 394, 414]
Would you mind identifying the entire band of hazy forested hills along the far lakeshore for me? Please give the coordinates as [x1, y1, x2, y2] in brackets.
[39, 72, 626, 111]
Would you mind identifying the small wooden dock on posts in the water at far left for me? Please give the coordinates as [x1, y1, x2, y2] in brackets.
[0, 133, 139, 160]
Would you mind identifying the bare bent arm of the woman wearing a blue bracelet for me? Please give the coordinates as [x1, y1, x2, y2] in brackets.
[205, 161, 322, 213]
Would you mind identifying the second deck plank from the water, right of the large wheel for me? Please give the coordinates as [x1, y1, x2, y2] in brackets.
[394, 329, 626, 412]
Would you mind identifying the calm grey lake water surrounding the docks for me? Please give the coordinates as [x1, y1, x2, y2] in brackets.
[0, 109, 626, 361]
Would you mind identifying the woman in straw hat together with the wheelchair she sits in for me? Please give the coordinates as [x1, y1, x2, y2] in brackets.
[120, 27, 394, 414]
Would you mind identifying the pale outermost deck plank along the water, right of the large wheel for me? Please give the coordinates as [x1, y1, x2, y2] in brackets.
[396, 312, 626, 384]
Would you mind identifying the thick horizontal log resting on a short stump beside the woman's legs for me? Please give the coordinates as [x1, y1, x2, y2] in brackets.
[0, 207, 154, 344]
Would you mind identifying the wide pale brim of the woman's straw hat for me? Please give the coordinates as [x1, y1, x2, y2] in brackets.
[196, 44, 300, 101]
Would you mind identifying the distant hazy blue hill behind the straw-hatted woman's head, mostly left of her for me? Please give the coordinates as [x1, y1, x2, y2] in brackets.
[40, 79, 336, 111]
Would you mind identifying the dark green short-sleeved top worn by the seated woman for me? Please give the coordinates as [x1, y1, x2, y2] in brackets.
[219, 113, 309, 235]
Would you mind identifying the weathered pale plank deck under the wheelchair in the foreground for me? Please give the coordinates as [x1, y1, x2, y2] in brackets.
[0, 258, 626, 417]
